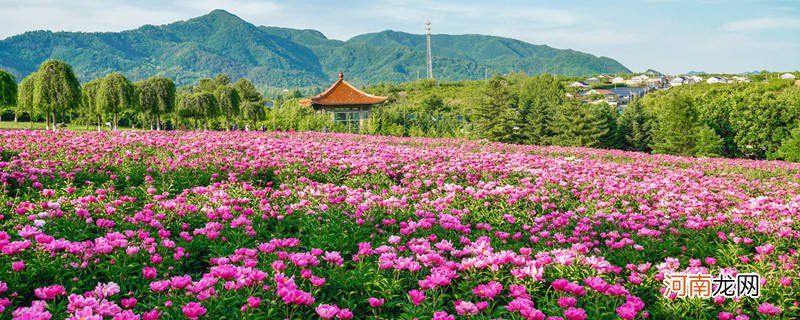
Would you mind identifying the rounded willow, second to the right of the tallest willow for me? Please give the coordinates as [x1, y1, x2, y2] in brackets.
[97, 72, 136, 131]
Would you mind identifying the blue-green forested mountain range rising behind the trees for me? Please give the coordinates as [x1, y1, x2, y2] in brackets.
[0, 10, 630, 88]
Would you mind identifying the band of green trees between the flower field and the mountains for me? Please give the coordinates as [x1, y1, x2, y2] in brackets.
[0, 60, 800, 161]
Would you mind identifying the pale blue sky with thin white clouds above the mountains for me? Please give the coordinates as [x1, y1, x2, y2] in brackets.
[0, 0, 800, 73]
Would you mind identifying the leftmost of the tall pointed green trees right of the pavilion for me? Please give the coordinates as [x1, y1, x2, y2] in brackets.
[475, 75, 521, 142]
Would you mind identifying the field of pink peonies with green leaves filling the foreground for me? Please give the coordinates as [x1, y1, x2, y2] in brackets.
[0, 131, 800, 320]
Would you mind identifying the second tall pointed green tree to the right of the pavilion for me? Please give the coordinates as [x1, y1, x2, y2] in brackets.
[519, 74, 566, 145]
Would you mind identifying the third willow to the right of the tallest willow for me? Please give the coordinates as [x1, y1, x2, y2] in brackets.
[135, 78, 175, 130]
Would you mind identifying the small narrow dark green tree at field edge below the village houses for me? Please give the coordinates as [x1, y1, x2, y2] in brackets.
[618, 99, 652, 152]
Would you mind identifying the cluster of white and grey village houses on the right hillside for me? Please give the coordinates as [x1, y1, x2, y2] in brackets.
[568, 72, 800, 108]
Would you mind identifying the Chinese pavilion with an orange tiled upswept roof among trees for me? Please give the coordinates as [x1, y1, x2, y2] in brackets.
[299, 72, 386, 131]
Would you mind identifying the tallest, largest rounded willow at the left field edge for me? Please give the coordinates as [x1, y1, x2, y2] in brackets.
[33, 60, 81, 131]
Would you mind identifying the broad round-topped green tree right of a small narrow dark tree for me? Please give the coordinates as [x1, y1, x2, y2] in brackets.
[650, 94, 695, 155]
